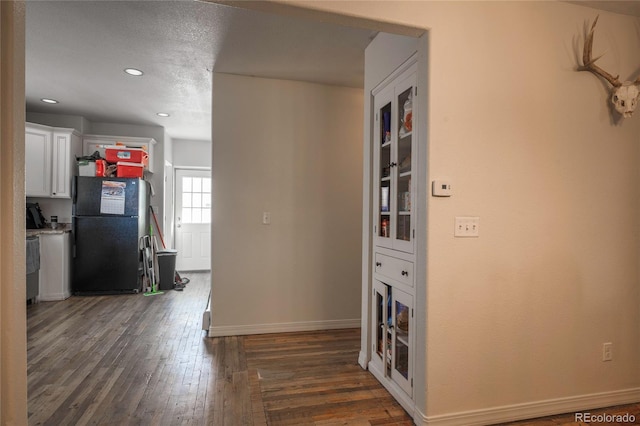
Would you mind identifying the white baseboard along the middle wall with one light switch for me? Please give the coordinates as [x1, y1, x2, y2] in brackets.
[209, 318, 360, 337]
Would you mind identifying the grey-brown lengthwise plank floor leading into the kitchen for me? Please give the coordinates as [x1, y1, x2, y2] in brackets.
[27, 273, 216, 425]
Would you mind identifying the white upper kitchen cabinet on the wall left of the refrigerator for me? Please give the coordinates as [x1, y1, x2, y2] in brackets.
[25, 123, 81, 198]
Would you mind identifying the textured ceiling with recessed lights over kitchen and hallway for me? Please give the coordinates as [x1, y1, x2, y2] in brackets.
[26, 1, 375, 140]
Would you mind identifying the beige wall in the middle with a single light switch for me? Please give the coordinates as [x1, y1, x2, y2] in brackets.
[212, 74, 363, 334]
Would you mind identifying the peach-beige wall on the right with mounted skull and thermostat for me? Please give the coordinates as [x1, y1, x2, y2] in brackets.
[284, 2, 640, 421]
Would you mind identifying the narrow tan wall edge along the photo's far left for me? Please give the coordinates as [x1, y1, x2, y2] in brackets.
[0, 1, 27, 426]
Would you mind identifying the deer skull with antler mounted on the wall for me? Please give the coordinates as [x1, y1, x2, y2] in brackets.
[578, 16, 640, 118]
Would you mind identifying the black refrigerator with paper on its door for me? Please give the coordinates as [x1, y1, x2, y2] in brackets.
[72, 176, 149, 294]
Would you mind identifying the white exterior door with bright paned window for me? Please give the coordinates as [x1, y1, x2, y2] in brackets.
[175, 169, 211, 271]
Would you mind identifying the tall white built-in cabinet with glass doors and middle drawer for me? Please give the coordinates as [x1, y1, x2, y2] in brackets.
[368, 59, 418, 408]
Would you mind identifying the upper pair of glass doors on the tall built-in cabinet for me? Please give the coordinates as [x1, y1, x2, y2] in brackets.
[373, 69, 416, 253]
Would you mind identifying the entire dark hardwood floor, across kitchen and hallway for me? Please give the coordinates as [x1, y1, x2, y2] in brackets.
[27, 273, 640, 426]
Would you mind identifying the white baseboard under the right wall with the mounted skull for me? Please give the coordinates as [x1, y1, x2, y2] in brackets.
[414, 388, 640, 426]
